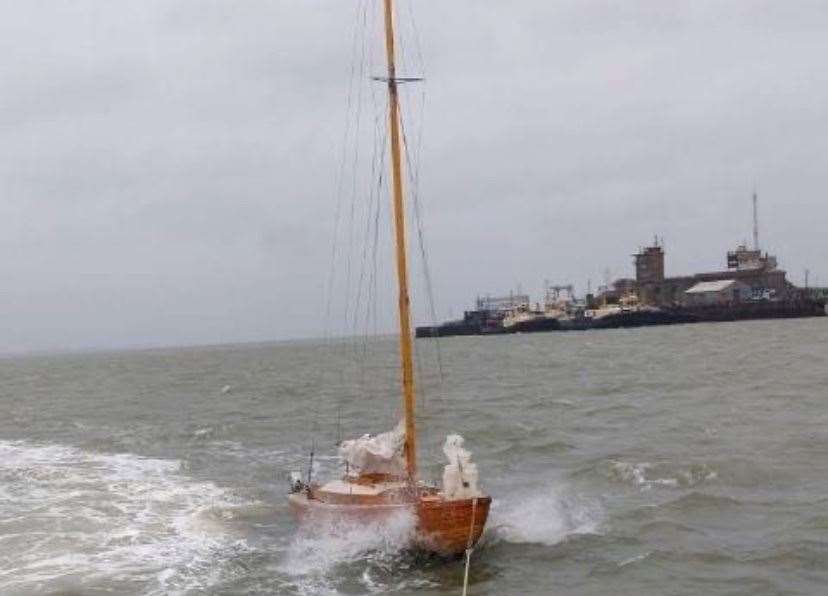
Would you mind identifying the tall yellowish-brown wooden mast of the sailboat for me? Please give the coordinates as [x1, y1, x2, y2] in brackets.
[384, 0, 417, 482]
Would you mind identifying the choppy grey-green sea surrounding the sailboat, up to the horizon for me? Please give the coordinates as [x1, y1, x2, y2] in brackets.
[0, 319, 828, 596]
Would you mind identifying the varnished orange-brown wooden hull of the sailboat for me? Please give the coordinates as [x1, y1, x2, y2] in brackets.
[288, 493, 492, 556]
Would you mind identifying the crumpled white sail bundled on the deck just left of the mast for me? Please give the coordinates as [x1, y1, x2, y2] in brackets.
[339, 421, 405, 476]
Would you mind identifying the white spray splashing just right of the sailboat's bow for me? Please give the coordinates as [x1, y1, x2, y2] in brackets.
[489, 485, 604, 546]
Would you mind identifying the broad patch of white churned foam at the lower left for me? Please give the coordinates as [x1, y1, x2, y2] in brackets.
[0, 441, 249, 594]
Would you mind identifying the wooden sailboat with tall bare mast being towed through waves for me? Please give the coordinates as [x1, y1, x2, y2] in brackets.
[288, 0, 492, 556]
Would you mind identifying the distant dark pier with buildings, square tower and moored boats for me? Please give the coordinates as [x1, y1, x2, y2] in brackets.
[417, 241, 826, 337]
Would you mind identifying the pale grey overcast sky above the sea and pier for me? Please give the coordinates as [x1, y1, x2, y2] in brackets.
[0, 0, 828, 352]
